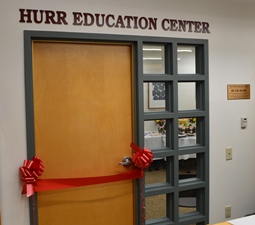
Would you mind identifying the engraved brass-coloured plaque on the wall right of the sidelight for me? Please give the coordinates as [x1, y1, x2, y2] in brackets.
[228, 84, 250, 100]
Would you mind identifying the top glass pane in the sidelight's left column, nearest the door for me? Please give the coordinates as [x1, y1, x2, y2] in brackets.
[143, 45, 165, 74]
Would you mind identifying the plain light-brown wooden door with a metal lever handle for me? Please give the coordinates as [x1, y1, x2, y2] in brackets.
[33, 41, 135, 225]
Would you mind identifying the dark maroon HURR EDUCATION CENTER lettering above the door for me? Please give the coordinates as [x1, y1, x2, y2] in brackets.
[19, 9, 210, 34]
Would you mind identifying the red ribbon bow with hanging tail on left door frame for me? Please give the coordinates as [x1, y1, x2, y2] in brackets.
[19, 156, 44, 197]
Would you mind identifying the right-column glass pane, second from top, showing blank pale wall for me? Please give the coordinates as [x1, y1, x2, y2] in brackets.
[178, 82, 196, 110]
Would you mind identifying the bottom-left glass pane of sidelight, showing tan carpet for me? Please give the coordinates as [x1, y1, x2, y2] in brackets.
[145, 195, 166, 220]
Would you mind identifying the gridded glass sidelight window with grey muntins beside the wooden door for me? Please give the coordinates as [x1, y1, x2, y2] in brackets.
[141, 40, 209, 225]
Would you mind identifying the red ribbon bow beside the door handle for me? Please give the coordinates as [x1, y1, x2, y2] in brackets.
[130, 143, 153, 169]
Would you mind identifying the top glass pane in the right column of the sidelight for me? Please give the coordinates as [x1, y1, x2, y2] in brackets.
[177, 46, 196, 74]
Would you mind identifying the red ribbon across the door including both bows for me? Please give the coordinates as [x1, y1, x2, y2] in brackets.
[19, 143, 153, 197]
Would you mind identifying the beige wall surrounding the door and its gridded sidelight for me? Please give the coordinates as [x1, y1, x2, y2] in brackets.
[0, 0, 255, 225]
